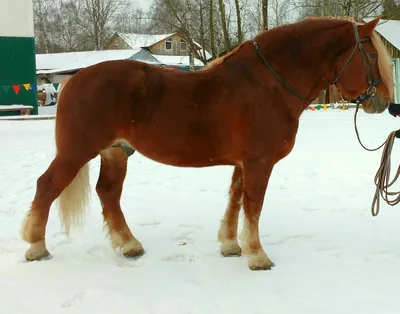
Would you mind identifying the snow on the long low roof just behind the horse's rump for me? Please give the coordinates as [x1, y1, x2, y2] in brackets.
[36, 49, 140, 74]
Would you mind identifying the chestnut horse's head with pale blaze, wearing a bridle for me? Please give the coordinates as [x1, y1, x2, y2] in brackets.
[334, 18, 394, 113]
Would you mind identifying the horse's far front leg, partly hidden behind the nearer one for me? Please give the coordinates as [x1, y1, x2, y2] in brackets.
[218, 166, 243, 256]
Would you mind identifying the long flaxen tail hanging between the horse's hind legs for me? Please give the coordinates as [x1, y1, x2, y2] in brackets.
[58, 163, 90, 235]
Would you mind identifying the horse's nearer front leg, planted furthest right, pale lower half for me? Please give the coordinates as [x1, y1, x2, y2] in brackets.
[241, 158, 274, 270]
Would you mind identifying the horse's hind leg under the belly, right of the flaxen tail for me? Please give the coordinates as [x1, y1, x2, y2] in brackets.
[96, 146, 144, 257]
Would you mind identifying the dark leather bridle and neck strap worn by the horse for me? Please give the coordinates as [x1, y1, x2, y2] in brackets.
[253, 24, 382, 104]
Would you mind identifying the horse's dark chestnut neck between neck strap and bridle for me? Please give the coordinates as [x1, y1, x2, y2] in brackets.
[255, 22, 349, 111]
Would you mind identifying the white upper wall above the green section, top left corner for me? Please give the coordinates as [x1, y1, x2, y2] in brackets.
[0, 0, 34, 37]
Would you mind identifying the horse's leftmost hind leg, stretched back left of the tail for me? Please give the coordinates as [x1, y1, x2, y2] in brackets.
[21, 155, 89, 261]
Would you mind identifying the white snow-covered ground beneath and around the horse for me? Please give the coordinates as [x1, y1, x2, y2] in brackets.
[0, 110, 400, 314]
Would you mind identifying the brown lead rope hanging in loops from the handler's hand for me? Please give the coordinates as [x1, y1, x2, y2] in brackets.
[354, 103, 400, 216]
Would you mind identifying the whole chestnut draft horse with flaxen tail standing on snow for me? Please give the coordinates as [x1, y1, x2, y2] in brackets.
[22, 18, 393, 270]
